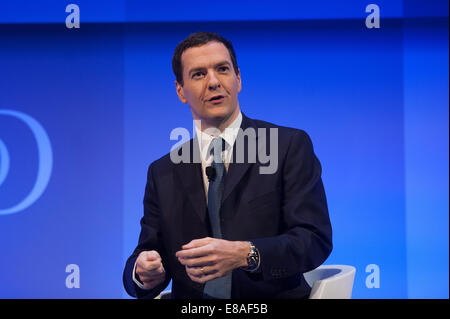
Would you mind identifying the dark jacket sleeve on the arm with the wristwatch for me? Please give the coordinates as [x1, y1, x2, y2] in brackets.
[253, 130, 332, 280]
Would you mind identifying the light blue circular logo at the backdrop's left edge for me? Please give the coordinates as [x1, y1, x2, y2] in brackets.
[0, 109, 53, 215]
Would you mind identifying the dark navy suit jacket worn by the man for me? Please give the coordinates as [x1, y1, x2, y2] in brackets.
[123, 114, 332, 298]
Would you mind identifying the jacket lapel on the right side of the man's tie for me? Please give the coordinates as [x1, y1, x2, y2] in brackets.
[222, 113, 258, 203]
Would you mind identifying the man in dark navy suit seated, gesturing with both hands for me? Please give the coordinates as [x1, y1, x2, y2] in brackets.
[123, 32, 332, 299]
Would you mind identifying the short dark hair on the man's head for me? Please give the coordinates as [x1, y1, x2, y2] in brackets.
[172, 32, 239, 86]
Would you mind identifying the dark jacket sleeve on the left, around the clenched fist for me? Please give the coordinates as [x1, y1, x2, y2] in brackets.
[123, 164, 171, 299]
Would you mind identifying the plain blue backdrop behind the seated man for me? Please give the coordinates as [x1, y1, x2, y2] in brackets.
[0, 0, 449, 298]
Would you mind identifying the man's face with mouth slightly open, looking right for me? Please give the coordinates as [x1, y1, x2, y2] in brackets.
[175, 42, 241, 128]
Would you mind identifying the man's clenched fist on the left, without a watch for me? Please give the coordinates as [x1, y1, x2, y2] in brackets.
[136, 250, 166, 289]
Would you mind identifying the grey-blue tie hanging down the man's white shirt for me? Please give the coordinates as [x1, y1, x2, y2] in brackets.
[203, 137, 231, 299]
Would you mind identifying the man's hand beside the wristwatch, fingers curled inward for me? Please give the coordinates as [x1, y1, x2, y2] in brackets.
[175, 237, 250, 283]
